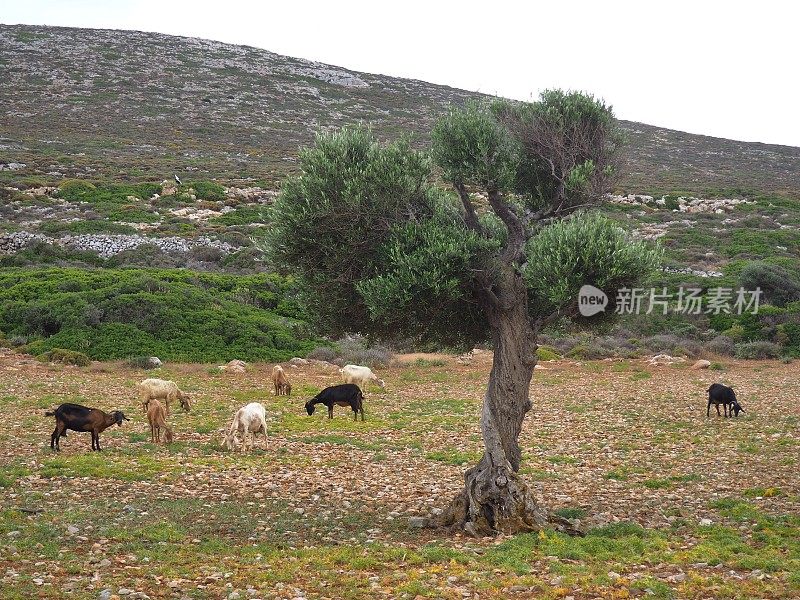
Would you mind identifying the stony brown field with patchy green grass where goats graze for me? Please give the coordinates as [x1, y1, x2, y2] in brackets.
[0, 350, 800, 599]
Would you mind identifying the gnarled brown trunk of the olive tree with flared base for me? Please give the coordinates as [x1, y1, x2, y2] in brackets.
[431, 273, 579, 536]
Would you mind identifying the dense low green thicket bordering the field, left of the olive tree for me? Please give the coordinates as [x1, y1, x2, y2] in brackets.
[0, 268, 318, 364]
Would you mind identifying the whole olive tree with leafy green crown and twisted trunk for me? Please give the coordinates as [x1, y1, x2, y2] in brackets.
[271, 91, 658, 535]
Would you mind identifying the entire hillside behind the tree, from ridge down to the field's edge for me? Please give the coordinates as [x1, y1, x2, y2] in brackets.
[0, 26, 800, 361]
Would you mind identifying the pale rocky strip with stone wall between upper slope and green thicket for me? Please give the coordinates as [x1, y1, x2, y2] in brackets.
[0, 182, 277, 268]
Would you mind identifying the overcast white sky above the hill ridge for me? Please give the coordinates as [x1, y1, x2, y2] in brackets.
[6, 0, 800, 146]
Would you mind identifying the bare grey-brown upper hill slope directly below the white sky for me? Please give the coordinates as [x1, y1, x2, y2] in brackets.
[0, 26, 800, 193]
